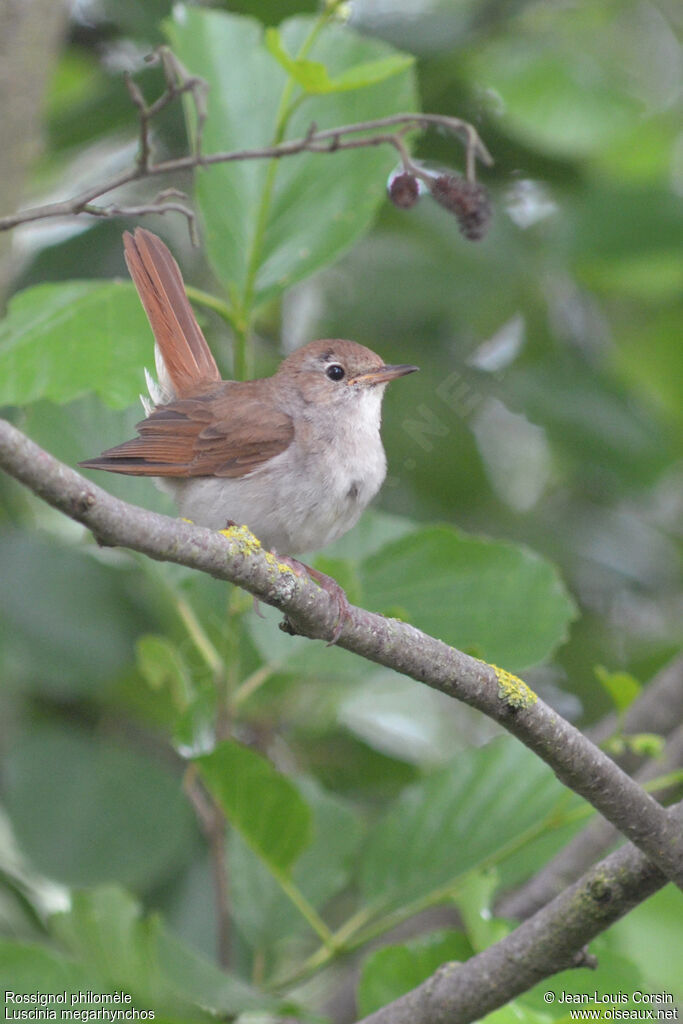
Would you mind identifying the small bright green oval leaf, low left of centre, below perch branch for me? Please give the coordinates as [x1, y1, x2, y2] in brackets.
[195, 740, 311, 873]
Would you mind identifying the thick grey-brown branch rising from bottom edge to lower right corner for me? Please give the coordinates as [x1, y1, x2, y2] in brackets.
[361, 804, 683, 1024]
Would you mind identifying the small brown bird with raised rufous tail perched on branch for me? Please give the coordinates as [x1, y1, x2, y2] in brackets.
[79, 227, 418, 636]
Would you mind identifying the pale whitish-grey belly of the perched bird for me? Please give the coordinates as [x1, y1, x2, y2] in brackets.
[163, 444, 386, 555]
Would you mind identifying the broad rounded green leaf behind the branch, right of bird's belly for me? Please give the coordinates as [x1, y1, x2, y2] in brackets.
[360, 526, 575, 671]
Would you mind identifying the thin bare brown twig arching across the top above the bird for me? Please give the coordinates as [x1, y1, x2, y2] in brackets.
[0, 46, 494, 241]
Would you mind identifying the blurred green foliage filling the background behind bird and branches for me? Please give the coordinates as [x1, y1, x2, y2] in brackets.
[0, 0, 683, 1020]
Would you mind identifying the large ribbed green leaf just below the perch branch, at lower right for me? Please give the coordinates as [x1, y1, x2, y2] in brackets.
[359, 737, 579, 908]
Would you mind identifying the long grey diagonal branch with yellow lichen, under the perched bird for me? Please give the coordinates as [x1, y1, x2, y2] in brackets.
[0, 420, 683, 887]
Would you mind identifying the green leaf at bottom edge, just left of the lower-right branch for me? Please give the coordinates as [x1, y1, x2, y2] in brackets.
[357, 931, 472, 1017]
